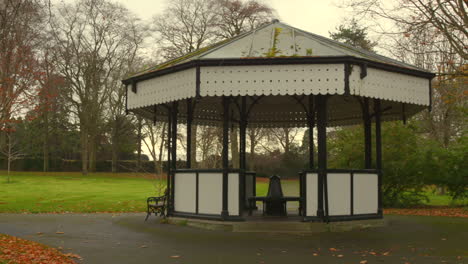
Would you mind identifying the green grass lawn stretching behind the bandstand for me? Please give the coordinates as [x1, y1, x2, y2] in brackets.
[0, 172, 466, 213]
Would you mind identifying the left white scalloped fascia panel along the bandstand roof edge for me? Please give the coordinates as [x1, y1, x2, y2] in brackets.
[127, 68, 196, 109]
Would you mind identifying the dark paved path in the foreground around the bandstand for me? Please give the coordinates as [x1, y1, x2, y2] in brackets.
[0, 214, 468, 264]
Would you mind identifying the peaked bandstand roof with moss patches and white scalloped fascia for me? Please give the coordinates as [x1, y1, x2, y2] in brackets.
[123, 20, 434, 126]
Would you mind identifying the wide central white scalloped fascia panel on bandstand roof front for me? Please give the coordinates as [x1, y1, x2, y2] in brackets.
[200, 64, 344, 96]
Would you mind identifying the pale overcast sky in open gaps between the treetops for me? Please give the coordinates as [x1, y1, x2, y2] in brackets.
[116, 0, 352, 37]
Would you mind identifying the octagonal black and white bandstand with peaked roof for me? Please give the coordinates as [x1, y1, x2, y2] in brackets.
[123, 20, 434, 222]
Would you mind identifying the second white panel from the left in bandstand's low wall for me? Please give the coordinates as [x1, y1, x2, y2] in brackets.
[198, 173, 223, 215]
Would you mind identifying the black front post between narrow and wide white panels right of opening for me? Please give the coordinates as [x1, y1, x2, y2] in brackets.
[316, 95, 328, 220]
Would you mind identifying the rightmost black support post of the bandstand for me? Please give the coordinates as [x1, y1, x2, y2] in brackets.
[374, 99, 382, 214]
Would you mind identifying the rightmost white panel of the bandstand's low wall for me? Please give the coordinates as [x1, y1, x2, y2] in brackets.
[353, 174, 379, 214]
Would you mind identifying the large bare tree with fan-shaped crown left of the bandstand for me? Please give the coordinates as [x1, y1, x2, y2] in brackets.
[49, 0, 142, 174]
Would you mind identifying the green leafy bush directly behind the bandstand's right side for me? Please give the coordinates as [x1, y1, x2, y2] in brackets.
[328, 122, 426, 207]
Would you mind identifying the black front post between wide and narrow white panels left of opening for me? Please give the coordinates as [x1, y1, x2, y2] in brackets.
[221, 96, 230, 219]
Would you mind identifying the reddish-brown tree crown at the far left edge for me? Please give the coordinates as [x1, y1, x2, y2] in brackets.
[0, 0, 45, 134]
